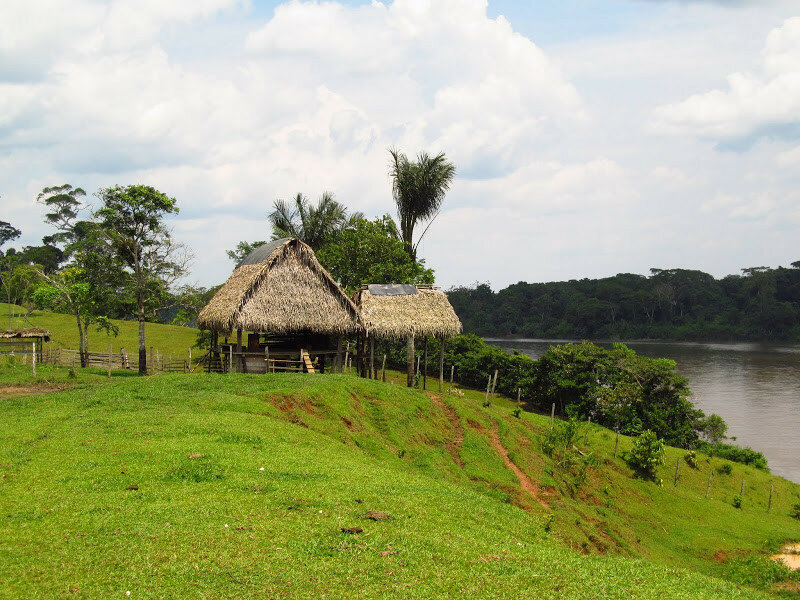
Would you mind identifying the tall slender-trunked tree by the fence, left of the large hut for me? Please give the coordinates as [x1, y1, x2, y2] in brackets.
[97, 185, 189, 375]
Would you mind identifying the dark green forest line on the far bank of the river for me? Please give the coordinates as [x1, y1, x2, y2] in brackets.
[448, 261, 800, 341]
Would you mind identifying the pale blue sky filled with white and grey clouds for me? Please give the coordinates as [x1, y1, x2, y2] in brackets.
[0, 0, 800, 289]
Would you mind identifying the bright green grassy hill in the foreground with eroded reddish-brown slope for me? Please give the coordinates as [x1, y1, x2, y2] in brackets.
[0, 358, 800, 598]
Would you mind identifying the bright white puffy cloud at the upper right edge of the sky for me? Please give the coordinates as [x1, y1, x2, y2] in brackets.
[653, 17, 800, 144]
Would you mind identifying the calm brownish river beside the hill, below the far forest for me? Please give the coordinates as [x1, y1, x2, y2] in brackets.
[486, 338, 800, 483]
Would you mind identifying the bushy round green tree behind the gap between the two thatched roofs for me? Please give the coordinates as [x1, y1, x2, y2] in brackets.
[317, 215, 434, 292]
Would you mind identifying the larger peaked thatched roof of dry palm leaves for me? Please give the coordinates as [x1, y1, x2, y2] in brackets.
[197, 238, 360, 334]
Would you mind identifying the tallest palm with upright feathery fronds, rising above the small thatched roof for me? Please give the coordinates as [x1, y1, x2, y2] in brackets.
[389, 148, 456, 260]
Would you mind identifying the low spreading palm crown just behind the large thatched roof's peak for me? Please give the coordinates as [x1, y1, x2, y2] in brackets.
[267, 192, 364, 251]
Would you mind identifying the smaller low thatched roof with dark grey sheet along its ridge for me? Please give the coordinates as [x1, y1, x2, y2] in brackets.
[354, 284, 461, 338]
